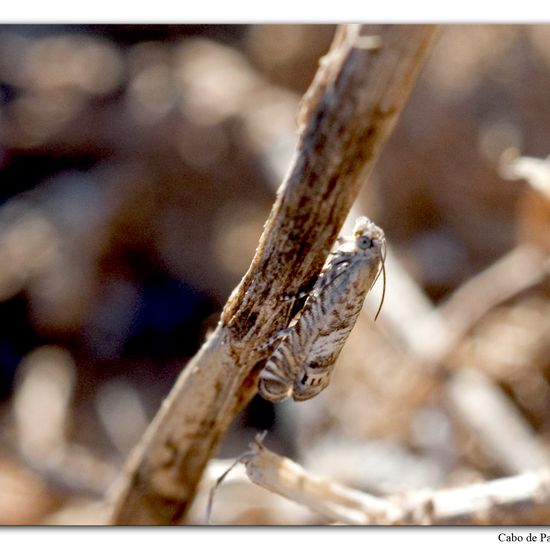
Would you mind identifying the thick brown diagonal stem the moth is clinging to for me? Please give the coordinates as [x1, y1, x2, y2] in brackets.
[104, 25, 436, 524]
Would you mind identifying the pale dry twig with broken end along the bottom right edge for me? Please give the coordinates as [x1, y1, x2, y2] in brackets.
[243, 440, 550, 525]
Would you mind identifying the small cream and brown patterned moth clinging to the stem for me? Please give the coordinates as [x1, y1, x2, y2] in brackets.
[258, 216, 385, 403]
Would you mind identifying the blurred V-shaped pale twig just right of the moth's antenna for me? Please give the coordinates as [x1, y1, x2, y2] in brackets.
[374, 245, 550, 366]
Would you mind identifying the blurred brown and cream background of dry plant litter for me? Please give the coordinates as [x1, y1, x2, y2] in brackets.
[0, 25, 550, 524]
